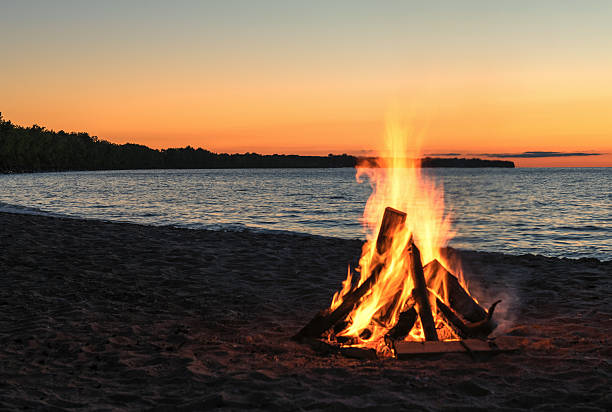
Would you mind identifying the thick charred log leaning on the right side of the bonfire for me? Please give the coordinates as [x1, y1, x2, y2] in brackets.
[423, 259, 487, 322]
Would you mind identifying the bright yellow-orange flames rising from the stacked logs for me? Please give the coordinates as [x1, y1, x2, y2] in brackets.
[330, 121, 467, 348]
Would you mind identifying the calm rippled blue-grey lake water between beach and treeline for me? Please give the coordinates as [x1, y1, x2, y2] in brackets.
[0, 168, 612, 260]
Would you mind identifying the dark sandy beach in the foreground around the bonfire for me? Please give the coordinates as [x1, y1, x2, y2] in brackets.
[0, 213, 612, 411]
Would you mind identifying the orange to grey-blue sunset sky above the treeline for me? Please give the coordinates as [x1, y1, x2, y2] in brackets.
[0, 0, 612, 166]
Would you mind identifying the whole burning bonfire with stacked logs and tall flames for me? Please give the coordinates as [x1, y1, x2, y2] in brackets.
[294, 121, 503, 357]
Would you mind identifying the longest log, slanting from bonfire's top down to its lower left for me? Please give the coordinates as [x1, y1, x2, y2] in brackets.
[292, 207, 406, 341]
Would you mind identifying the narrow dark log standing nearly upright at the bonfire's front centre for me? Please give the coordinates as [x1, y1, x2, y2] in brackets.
[407, 239, 438, 341]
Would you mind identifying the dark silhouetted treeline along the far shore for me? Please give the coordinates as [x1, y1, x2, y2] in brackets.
[0, 113, 514, 173]
